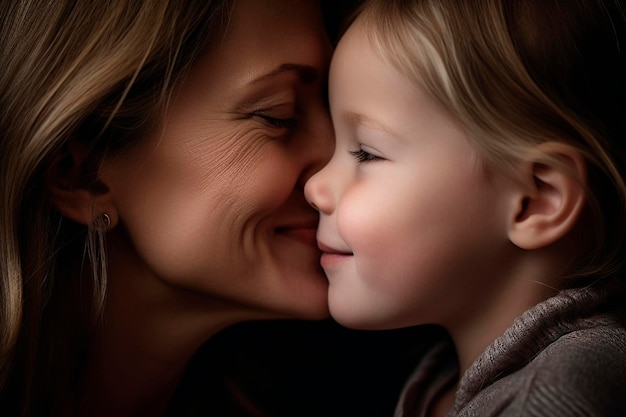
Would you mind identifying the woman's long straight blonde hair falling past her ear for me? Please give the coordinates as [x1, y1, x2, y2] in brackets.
[0, 0, 230, 415]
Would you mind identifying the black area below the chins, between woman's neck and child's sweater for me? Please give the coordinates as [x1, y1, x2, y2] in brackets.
[172, 320, 442, 417]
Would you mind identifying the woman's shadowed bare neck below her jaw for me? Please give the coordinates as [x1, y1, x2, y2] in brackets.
[79, 232, 245, 417]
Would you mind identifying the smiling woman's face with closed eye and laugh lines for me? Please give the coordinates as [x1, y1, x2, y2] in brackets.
[101, 0, 333, 318]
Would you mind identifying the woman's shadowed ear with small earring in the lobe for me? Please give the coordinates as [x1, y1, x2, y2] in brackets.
[46, 142, 118, 229]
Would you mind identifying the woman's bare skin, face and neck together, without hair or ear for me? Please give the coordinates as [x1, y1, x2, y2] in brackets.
[76, 0, 333, 416]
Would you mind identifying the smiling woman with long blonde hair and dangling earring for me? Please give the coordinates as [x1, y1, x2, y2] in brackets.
[0, 0, 333, 416]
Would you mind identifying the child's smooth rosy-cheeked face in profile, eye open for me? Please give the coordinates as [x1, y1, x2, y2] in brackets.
[305, 21, 509, 329]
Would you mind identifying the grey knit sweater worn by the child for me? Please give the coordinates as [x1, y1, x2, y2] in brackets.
[396, 279, 626, 417]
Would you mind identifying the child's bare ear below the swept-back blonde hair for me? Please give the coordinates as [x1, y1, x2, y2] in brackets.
[509, 142, 587, 249]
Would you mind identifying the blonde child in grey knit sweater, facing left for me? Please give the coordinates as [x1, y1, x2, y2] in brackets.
[305, 0, 626, 416]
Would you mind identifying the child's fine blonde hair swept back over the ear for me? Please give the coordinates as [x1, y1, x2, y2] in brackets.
[357, 0, 626, 282]
